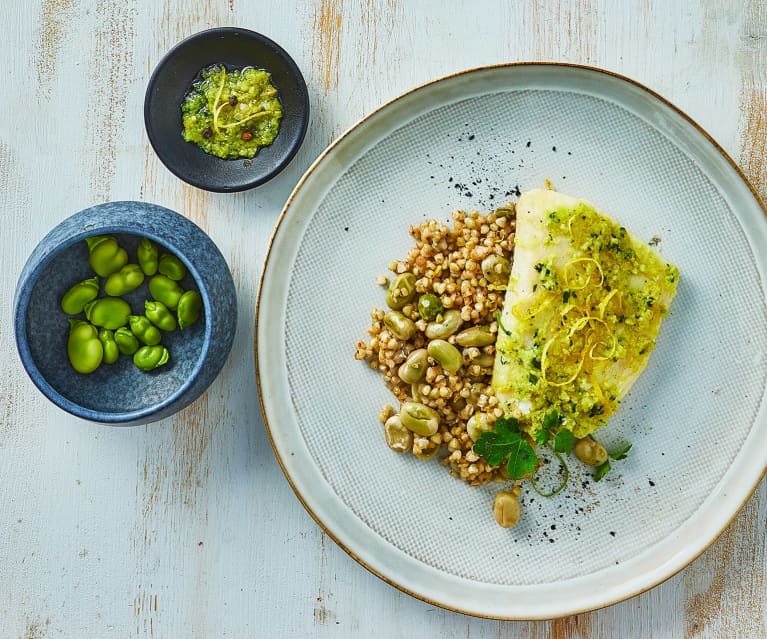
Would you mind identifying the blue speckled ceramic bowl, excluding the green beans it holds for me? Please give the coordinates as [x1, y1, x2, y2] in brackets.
[14, 202, 237, 425]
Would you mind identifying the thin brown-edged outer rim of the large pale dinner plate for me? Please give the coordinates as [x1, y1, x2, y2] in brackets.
[253, 61, 767, 621]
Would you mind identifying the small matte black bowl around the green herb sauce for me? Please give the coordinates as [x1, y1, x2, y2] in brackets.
[144, 27, 309, 193]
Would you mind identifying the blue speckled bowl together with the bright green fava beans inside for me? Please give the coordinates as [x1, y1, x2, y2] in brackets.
[14, 202, 237, 425]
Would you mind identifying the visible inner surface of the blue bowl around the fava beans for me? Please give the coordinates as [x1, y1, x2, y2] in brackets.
[25, 233, 205, 414]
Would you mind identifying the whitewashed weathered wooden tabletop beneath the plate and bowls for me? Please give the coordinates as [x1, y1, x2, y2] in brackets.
[0, 0, 767, 639]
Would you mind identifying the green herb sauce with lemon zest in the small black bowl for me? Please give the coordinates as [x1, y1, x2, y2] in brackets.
[181, 65, 282, 160]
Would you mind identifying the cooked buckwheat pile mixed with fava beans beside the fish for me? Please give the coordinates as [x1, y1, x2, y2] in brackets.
[355, 204, 514, 485]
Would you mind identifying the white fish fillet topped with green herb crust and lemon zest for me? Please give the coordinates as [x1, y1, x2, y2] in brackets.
[492, 189, 679, 437]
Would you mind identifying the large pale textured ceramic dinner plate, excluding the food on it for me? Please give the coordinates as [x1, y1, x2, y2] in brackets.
[256, 64, 767, 619]
